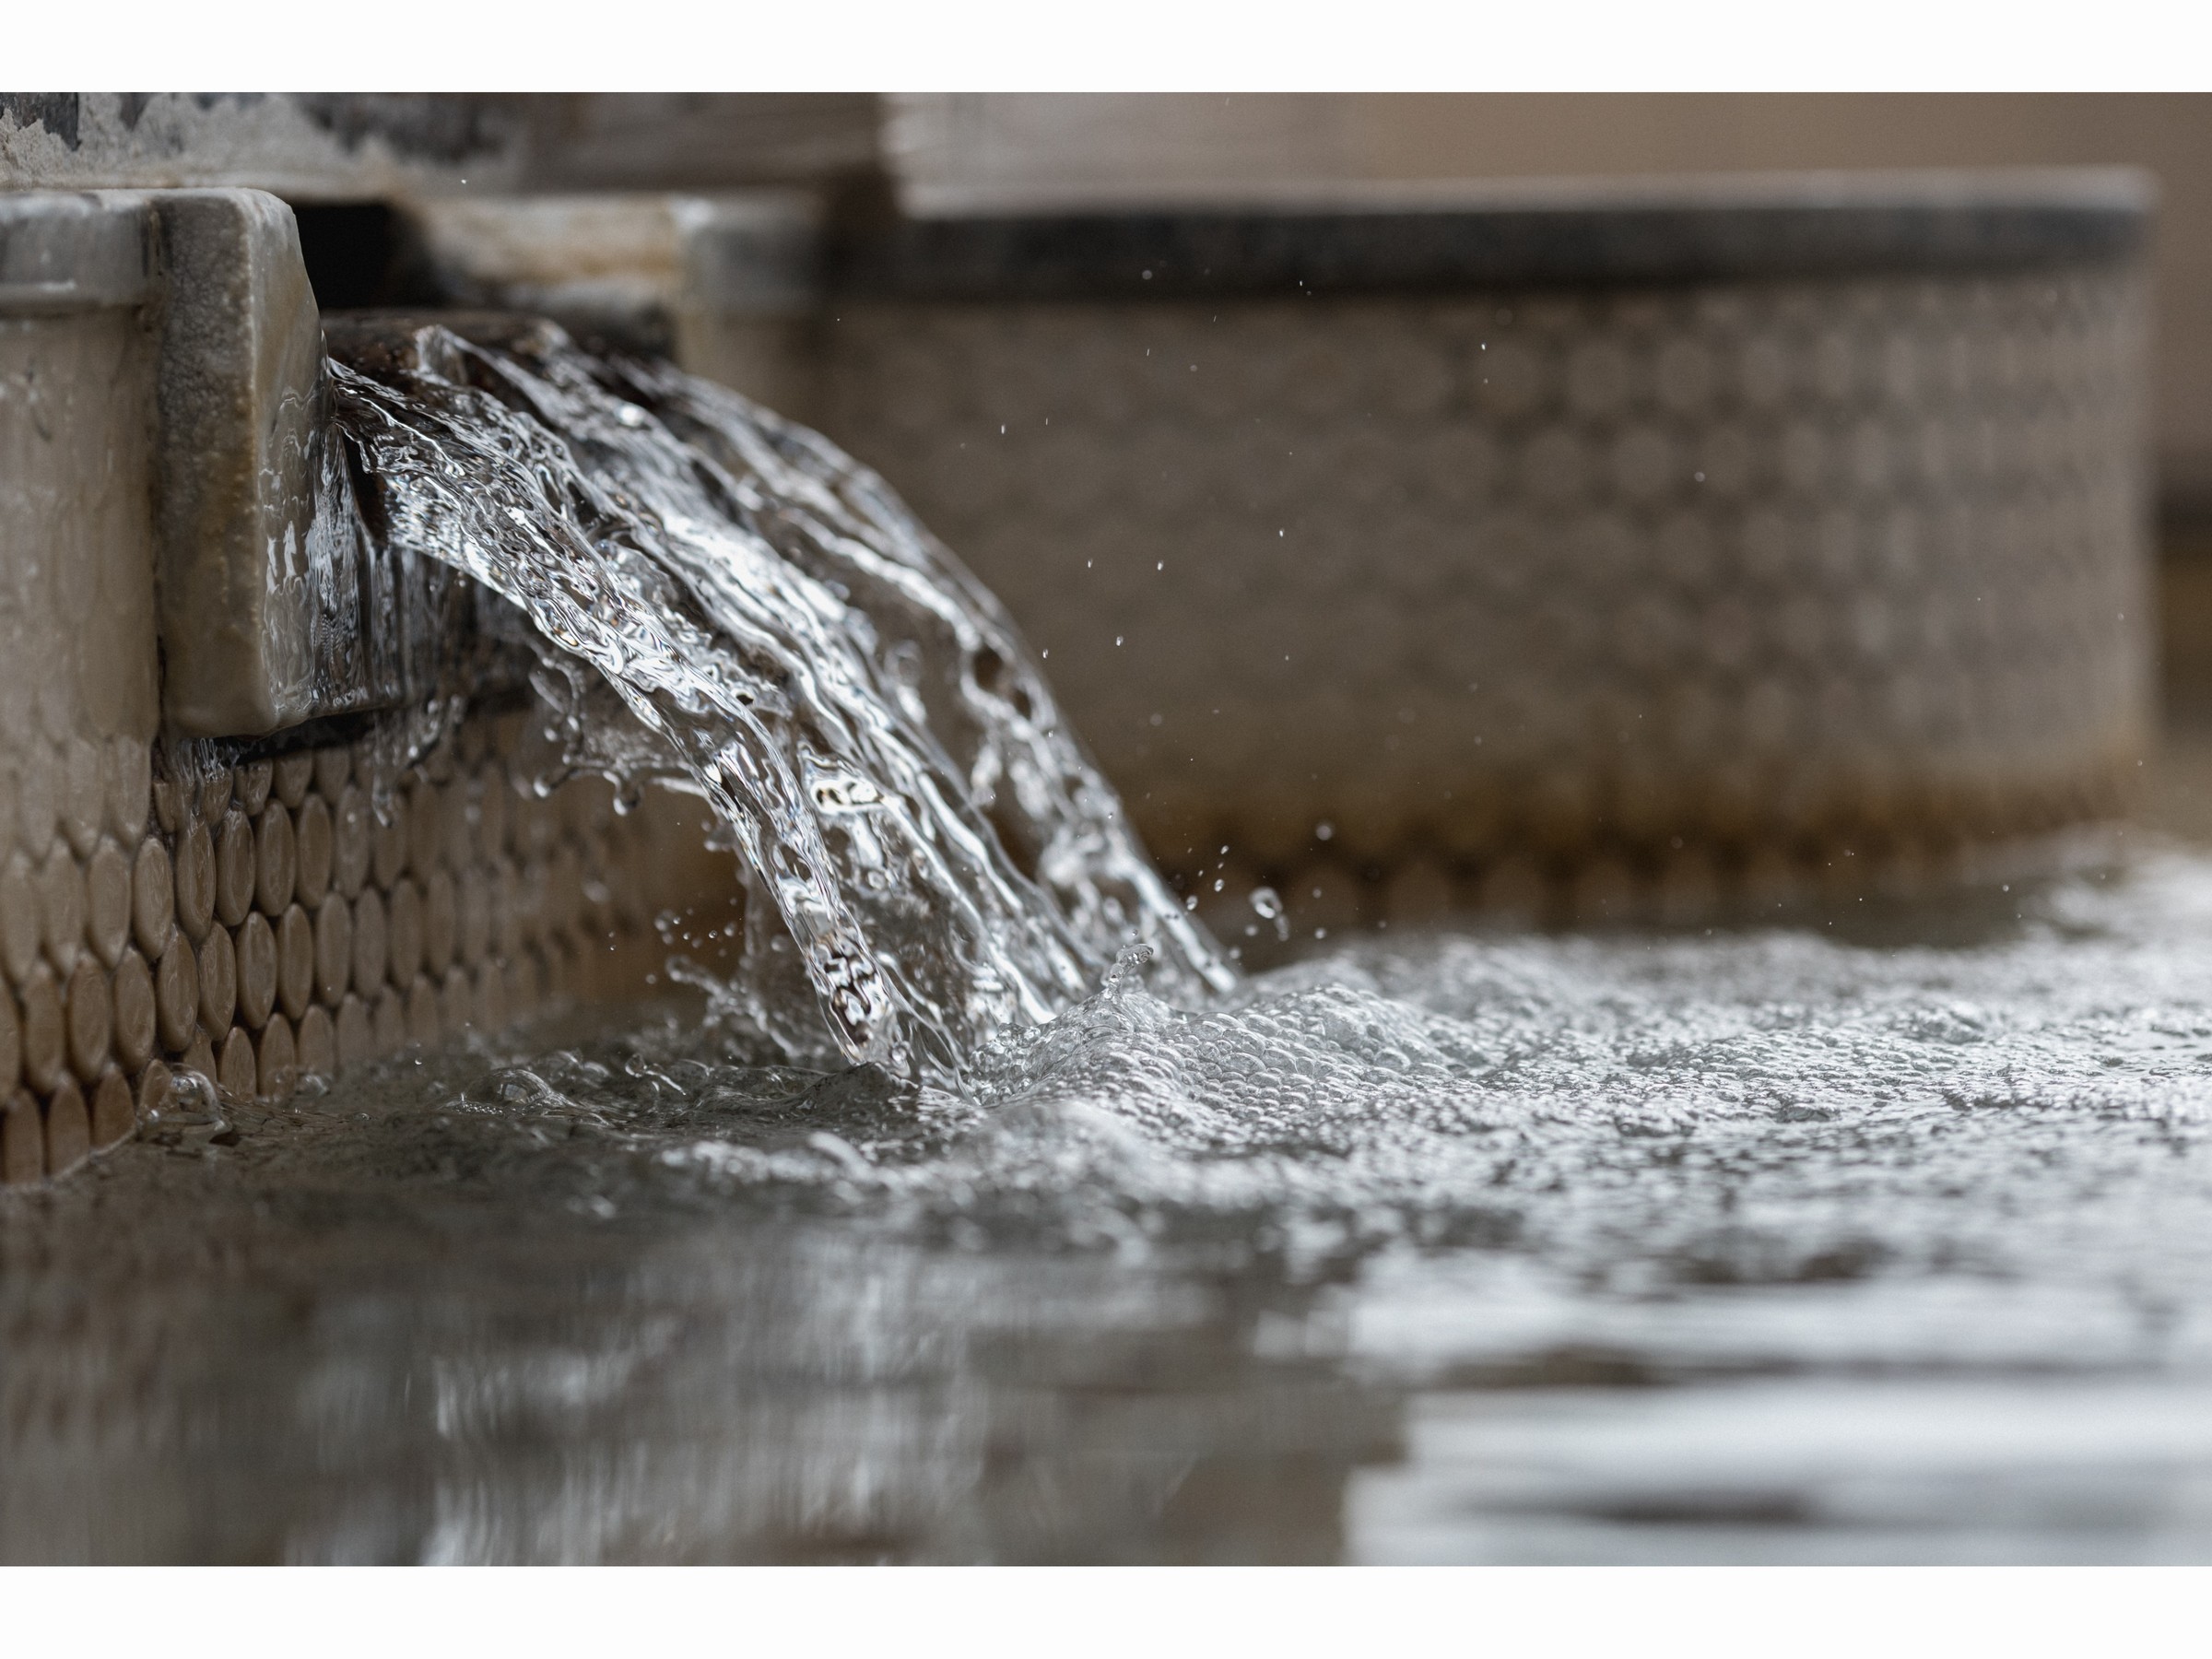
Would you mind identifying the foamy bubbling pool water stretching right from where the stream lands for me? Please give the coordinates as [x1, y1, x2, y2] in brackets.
[641, 858, 2212, 1354]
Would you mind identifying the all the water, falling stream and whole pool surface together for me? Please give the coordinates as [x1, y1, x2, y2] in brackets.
[0, 321, 2212, 1561]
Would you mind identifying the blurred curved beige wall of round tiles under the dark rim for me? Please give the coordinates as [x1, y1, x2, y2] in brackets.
[825, 267, 2150, 935]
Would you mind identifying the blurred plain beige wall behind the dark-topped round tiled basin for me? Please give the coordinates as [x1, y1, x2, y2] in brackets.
[885, 93, 2212, 520]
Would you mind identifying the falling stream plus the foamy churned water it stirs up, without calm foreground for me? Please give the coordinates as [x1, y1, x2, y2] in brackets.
[307, 325, 2212, 1380]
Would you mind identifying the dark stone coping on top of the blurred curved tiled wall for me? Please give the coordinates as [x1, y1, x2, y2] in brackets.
[825, 168, 2152, 300]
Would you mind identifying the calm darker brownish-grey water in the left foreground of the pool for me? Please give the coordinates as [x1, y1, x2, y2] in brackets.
[0, 1053, 1394, 1561]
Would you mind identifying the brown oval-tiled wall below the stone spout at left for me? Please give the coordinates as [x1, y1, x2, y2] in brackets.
[0, 714, 725, 1183]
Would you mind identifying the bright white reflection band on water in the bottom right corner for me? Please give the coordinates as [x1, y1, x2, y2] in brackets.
[1349, 1378, 2212, 1566]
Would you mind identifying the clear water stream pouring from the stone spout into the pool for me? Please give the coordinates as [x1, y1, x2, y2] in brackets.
[330, 323, 1234, 1077]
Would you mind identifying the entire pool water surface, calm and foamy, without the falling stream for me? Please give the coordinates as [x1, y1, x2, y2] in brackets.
[13, 852, 2212, 1561]
